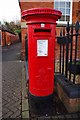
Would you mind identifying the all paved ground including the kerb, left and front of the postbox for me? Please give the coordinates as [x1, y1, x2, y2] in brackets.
[0, 43, 80, 120]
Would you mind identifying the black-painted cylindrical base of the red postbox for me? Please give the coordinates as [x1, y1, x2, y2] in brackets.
[29, 93, 53, 115]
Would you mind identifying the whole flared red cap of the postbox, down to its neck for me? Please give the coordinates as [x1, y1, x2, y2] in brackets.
[22, 8, 62, 24]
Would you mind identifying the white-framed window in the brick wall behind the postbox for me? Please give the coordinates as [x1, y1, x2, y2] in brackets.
[54, 0, 72, 24]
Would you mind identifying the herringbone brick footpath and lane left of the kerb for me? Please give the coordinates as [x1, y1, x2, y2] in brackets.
[2, 43, 22, 120]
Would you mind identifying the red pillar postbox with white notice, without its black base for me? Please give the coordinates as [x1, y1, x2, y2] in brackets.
[22, 8, 61, 115]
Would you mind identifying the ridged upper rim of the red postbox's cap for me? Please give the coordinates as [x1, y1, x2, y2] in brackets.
[22, 8, 62, 18]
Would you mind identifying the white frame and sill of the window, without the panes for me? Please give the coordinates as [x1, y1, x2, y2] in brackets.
[54, 0, 73, 24]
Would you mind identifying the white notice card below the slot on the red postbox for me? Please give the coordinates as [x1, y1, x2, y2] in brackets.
[37, 40, 48, 56]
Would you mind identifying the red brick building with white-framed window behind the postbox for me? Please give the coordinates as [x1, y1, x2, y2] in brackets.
[19, 0, 80, 60]
